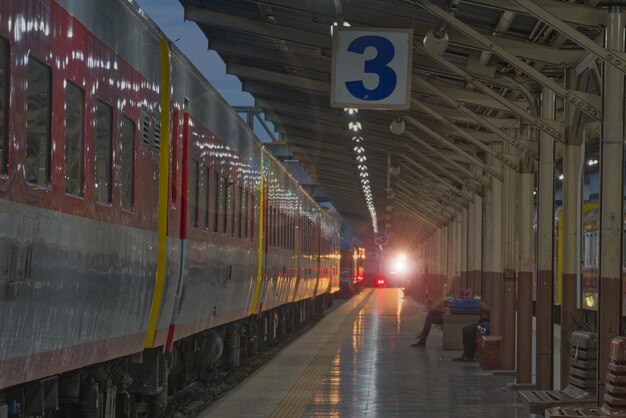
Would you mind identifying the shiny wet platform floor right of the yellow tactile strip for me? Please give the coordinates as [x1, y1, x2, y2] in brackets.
[304, 289, 529, 418]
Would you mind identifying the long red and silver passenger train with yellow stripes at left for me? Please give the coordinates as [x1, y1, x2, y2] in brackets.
[0, 0, 340, 418]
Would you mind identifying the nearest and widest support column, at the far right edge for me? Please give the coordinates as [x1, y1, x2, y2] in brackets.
[597, 6, 624, 398]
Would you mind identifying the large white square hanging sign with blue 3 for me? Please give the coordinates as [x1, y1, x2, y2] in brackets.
[331, 27, 413, 109]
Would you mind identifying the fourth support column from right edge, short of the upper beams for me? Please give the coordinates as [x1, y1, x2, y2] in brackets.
[515, 152, 535, 385]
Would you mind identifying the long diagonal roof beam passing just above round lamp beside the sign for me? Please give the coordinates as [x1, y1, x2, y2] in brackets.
[414, 0, 602, 119]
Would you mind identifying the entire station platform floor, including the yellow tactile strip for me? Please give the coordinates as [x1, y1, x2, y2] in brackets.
[199, 288, 531, 418]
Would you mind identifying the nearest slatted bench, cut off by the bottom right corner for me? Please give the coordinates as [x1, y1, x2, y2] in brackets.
[545, 337, 626, 418]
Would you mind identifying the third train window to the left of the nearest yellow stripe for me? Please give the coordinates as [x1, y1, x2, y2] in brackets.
[65, 81, 85, 196]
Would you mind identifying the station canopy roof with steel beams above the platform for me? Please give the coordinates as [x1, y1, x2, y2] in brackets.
[180, 0, 604, 246]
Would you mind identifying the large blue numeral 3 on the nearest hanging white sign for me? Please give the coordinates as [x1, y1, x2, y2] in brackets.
[346, 35, 398, 101]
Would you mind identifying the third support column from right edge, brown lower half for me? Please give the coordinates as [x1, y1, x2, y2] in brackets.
[535, 86, 555, 389]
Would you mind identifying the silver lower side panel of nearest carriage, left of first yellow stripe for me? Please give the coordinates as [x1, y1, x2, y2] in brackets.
[0, 200, 156, 388]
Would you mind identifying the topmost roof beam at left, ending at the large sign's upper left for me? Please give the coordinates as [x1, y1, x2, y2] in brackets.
[185, 6, 332, 49]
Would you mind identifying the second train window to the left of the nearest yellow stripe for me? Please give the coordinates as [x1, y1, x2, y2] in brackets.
[96, 100, 113, 204]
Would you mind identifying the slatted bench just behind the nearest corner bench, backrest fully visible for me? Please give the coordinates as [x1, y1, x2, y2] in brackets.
[520, 331, 598, 416]
